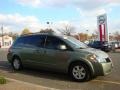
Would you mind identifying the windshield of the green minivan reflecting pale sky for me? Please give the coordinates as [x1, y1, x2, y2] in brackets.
[64, 36, 88, 49]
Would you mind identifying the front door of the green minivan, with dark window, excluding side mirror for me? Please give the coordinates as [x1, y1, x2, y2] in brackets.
[43, 36, 70, 69]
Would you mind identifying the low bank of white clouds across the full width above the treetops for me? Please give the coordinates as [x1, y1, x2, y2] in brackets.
[0, 10, 120, 33]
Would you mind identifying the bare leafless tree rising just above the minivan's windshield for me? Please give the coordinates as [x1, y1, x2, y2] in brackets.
[58, 24, 75, 36]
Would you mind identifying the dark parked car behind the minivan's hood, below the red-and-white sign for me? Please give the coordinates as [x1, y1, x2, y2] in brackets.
[88, 41, 112, 52]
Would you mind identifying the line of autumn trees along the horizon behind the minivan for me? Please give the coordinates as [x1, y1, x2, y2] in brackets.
[0, 26, 120, 42]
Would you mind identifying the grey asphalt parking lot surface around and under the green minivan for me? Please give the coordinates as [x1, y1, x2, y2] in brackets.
[0, 49, 120, 90]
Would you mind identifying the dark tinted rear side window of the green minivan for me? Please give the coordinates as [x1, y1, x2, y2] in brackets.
[13, 35, 46, 48]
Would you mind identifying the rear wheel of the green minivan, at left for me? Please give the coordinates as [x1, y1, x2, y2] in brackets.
[12, 57, 22, 71]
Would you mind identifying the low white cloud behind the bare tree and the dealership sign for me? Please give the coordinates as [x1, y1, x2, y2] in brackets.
[54, 17, 120, 34]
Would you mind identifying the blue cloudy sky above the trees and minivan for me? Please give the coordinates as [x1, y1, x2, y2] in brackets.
[0, 0, 120, 33]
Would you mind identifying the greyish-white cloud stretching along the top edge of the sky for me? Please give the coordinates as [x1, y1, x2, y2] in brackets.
[17, 0, 120, 16]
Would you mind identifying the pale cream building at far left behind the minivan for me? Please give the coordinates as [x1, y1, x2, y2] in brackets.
[0, 35, 13, 48]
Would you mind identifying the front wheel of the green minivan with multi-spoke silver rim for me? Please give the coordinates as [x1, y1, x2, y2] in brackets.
[69, 63, 90, 82]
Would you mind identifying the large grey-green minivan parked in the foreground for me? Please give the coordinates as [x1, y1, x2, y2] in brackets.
[7, 33, 113, 82]
